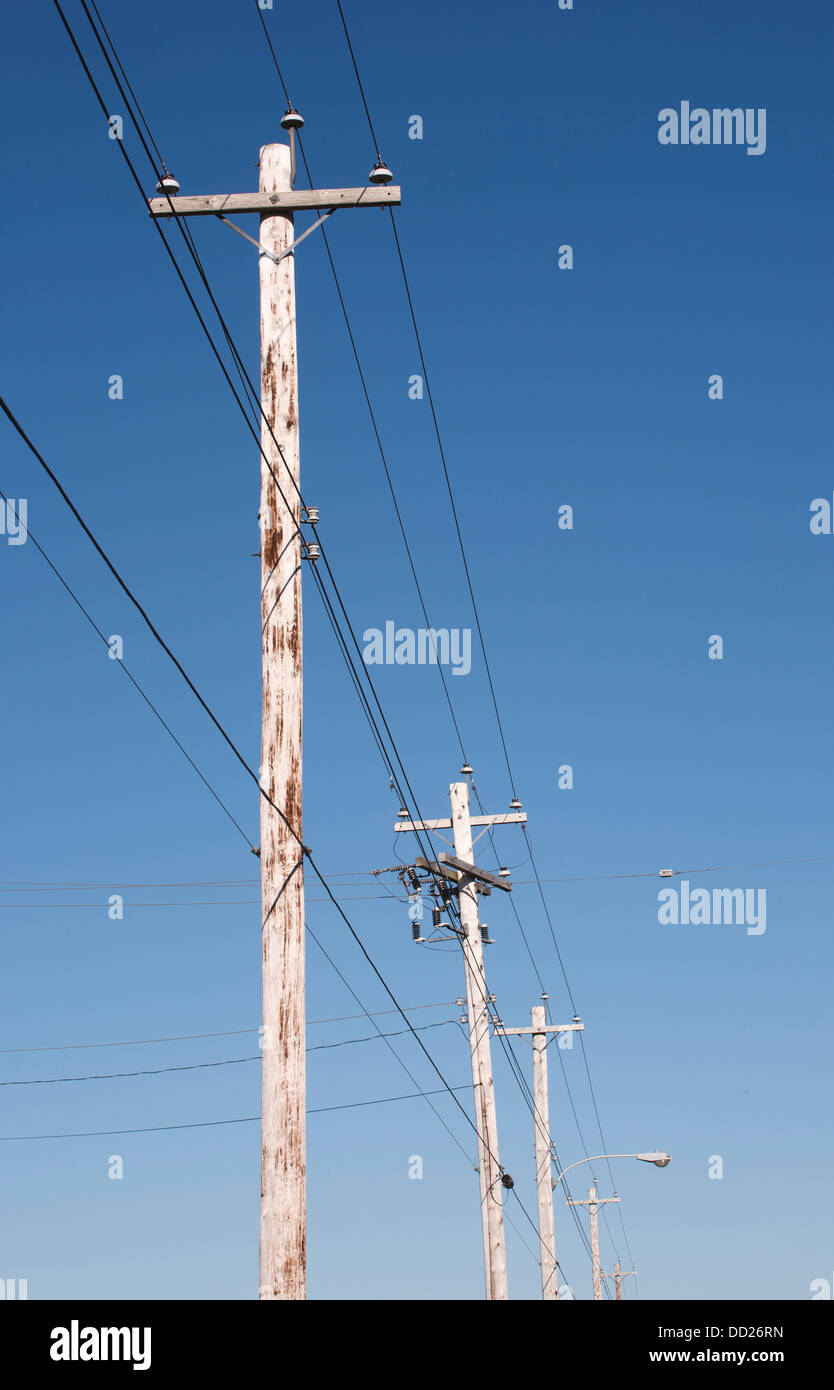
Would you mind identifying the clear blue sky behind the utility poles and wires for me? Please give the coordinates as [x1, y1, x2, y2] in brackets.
[0, 0, 834, 1300]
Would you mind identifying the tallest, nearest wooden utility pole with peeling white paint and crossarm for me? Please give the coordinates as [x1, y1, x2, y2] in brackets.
[149, 122, 400, 1300]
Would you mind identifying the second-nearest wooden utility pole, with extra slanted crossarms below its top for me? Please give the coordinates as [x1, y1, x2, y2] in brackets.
[393, 765, 527, 1298]
